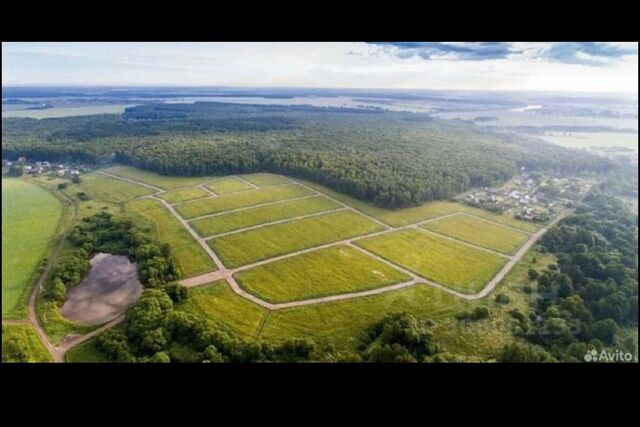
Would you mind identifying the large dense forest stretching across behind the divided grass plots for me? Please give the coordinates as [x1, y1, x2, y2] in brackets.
[2, 102, 612, 207]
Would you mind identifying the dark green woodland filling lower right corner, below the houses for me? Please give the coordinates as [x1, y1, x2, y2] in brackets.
[501, 192, 638, 362]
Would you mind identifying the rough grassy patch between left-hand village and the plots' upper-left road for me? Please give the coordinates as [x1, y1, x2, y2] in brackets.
[72, 173, 154, 204]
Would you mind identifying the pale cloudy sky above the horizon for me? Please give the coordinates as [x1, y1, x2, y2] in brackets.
[2, 42, 638, 94]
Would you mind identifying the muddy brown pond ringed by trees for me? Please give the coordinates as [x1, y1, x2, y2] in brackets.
[60, 253, 142, 325]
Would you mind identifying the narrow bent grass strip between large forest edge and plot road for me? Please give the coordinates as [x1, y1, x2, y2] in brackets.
[298, 179, 539, 232]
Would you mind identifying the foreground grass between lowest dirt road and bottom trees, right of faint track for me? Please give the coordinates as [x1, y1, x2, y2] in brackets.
[260, 285, 470, 350]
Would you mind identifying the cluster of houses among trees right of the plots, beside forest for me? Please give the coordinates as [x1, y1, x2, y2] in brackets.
[458, 167, 590, 222]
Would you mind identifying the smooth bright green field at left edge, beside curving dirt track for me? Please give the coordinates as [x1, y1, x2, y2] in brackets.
[2, 178, 63, 319]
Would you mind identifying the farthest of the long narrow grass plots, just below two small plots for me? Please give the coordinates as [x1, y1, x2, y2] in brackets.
[176, 185, 311, 219]
